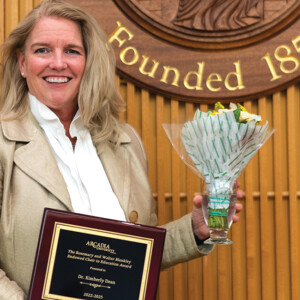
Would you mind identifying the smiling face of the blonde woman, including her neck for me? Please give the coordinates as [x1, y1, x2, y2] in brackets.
[18, 17, 85, 116]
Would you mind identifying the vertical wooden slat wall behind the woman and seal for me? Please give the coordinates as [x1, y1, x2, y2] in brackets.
[0, 0, 300, 300]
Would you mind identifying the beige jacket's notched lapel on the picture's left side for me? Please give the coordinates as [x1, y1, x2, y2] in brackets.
[2, 113, 73, 211]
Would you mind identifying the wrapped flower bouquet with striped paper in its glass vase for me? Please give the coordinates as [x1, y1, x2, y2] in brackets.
[163, 102, 274, 244]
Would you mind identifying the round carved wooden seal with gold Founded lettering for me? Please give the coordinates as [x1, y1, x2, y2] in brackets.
[68, 0, 300, 102]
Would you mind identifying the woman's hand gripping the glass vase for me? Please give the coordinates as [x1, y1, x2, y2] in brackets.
[192, 182, 245, 240]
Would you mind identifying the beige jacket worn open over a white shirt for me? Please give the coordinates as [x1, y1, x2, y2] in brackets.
[0, 113, 211, 300]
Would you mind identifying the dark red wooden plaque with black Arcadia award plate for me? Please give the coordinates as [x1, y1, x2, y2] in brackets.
[29, 209, 165, 300]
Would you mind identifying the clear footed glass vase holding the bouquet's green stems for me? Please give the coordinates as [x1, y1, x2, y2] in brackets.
[202, 192, 237, 244]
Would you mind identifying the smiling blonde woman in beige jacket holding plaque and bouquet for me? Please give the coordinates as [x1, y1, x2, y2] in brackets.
[0, 0, 241, 299]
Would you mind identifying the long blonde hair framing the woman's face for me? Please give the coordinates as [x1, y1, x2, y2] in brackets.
[0, 0, 125, 144]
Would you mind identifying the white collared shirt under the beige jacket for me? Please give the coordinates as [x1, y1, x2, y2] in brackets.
[29, 94, 126, 221]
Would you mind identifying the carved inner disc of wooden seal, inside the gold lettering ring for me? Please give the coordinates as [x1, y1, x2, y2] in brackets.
[115, 0, 300, 49]
